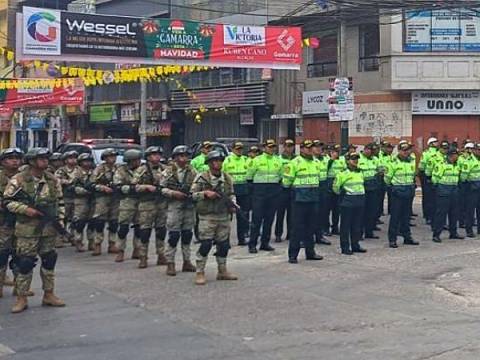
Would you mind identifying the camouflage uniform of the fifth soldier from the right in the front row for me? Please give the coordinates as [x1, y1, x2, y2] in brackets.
[91, 163, 120, 250]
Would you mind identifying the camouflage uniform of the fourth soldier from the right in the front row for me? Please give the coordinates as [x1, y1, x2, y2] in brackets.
[113, 164, 140, 252]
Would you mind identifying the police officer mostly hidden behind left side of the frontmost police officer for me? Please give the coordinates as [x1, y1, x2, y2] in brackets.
[275, 139, 295, 243]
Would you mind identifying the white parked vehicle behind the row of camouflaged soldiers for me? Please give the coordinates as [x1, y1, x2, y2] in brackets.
[55, 139, 143, 164]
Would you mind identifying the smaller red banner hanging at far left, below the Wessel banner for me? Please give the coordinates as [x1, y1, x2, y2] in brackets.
[0, 79, 85, 113]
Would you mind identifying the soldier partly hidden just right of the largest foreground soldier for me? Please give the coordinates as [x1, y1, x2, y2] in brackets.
[55, 150, 78, 245]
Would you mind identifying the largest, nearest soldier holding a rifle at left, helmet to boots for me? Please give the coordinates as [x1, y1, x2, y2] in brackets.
[4, 148, 65, 313]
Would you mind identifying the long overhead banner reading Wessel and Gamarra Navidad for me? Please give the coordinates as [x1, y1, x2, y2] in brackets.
[17, 7, 302, 69]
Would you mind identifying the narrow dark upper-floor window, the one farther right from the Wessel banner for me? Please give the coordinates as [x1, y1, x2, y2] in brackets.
[358, 24, 380, 71]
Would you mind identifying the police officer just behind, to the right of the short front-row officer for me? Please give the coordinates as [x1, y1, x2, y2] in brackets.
[358, 143, 379, 239]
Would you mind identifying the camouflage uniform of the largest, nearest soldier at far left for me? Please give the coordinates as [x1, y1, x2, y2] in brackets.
[4, 168, 65, 296]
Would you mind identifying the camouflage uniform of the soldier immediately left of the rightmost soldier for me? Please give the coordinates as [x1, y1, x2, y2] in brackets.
[160, 163, 196, 270]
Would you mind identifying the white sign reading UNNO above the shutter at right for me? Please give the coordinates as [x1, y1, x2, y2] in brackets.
[412, 90, 480, 115]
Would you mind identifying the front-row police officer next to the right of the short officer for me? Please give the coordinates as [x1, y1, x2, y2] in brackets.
[384, 143, 418, 249]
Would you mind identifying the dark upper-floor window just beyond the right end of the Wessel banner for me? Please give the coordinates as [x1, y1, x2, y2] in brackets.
[307, 34, 337, 77]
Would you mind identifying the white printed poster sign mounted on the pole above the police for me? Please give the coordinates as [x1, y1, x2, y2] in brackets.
[328, 78, 355, 121]
